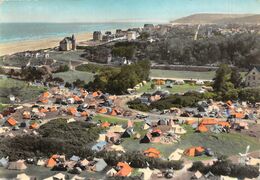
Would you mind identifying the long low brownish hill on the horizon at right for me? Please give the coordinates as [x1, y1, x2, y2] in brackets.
[171, 14, 260, 24]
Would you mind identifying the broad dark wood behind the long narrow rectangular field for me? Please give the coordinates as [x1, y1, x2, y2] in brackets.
[151, 33, 260, 68]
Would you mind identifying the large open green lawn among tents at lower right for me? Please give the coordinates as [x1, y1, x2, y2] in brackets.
[122, 126, 260, 160]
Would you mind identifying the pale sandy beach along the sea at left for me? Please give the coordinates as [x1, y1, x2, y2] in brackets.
[0, 33, 93, 56]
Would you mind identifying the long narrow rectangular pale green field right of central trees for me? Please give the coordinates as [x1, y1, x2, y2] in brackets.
[150, 69, 215, 80]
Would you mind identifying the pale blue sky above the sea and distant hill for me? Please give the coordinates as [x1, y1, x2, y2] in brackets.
[0, 0, 260, 22]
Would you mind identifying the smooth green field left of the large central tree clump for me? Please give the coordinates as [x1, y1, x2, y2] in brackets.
[53, 71, 94, 83]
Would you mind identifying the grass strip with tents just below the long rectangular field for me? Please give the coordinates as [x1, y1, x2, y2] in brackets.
[137, 82, 202, 94]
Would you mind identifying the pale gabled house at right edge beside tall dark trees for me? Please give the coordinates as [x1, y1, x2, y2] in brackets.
[245, 66, 260, 87]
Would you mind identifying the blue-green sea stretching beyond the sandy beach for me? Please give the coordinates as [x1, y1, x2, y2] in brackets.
[0, 23, 144, 43]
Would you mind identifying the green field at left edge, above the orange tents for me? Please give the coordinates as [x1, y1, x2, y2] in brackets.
[0, 78, 46, 104]
